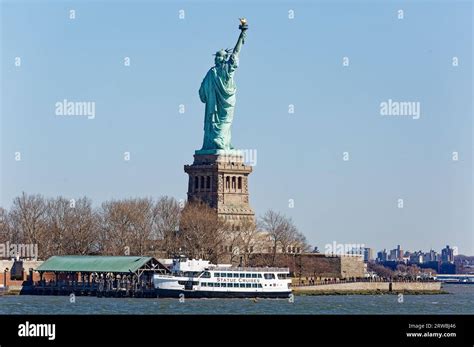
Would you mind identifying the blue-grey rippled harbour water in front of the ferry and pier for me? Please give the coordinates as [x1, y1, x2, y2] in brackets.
[0, 284, 474, 314]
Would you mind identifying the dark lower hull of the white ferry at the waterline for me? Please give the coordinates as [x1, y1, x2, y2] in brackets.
[156, 289, 291, 299]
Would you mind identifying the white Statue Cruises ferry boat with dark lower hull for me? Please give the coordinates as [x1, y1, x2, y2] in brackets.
[153, 258, 291, 298]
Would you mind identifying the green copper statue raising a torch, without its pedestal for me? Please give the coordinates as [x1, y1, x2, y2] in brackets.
[196, 18, 248, 154]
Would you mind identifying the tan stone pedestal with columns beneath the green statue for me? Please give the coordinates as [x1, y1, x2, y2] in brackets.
[184, 151, 255, 229]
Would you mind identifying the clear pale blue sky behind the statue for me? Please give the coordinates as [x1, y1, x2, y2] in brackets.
[0, 0, 474, 255]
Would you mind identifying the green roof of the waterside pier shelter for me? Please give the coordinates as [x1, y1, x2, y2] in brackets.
[36, 255, 162, 273]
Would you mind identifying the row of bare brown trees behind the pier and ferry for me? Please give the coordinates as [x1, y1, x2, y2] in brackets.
[0, 193, 309, 263]
